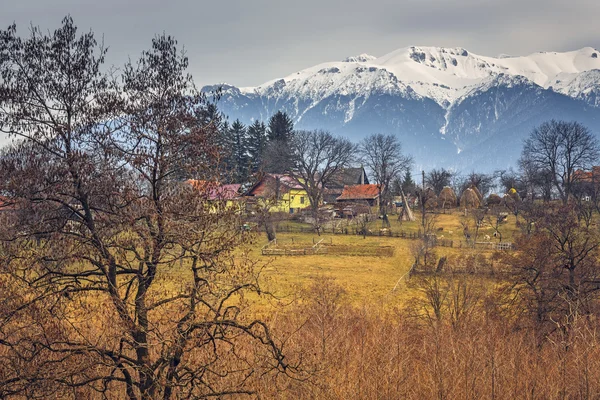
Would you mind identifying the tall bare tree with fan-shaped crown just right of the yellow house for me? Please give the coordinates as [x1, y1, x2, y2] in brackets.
[290, 131, 356, 234]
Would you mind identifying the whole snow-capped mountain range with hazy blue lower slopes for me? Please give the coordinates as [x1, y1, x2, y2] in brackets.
[203, 47, 600, 170]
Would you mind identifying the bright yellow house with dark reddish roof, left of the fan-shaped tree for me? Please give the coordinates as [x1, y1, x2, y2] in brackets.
[246, 174, 310, 214]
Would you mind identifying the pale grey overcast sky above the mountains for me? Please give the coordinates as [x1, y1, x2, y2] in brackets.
[0, 0, 600, 86]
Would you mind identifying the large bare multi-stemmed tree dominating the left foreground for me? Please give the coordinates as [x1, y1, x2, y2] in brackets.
[0, 18, 285, 399]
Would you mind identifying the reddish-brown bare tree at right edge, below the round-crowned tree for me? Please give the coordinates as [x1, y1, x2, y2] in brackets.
[502, 205, 600, 333]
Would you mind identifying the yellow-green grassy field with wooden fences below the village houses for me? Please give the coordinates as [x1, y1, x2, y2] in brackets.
[252, 211, 518, 306]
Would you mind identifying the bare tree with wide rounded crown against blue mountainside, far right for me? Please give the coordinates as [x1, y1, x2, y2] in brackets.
[519, 120, 600, 204]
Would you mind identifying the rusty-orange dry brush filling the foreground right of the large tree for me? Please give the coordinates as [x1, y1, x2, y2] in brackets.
[254, 276, 600, 399]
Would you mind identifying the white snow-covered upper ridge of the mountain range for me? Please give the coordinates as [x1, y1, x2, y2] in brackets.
[232, 46, 600, 109]
